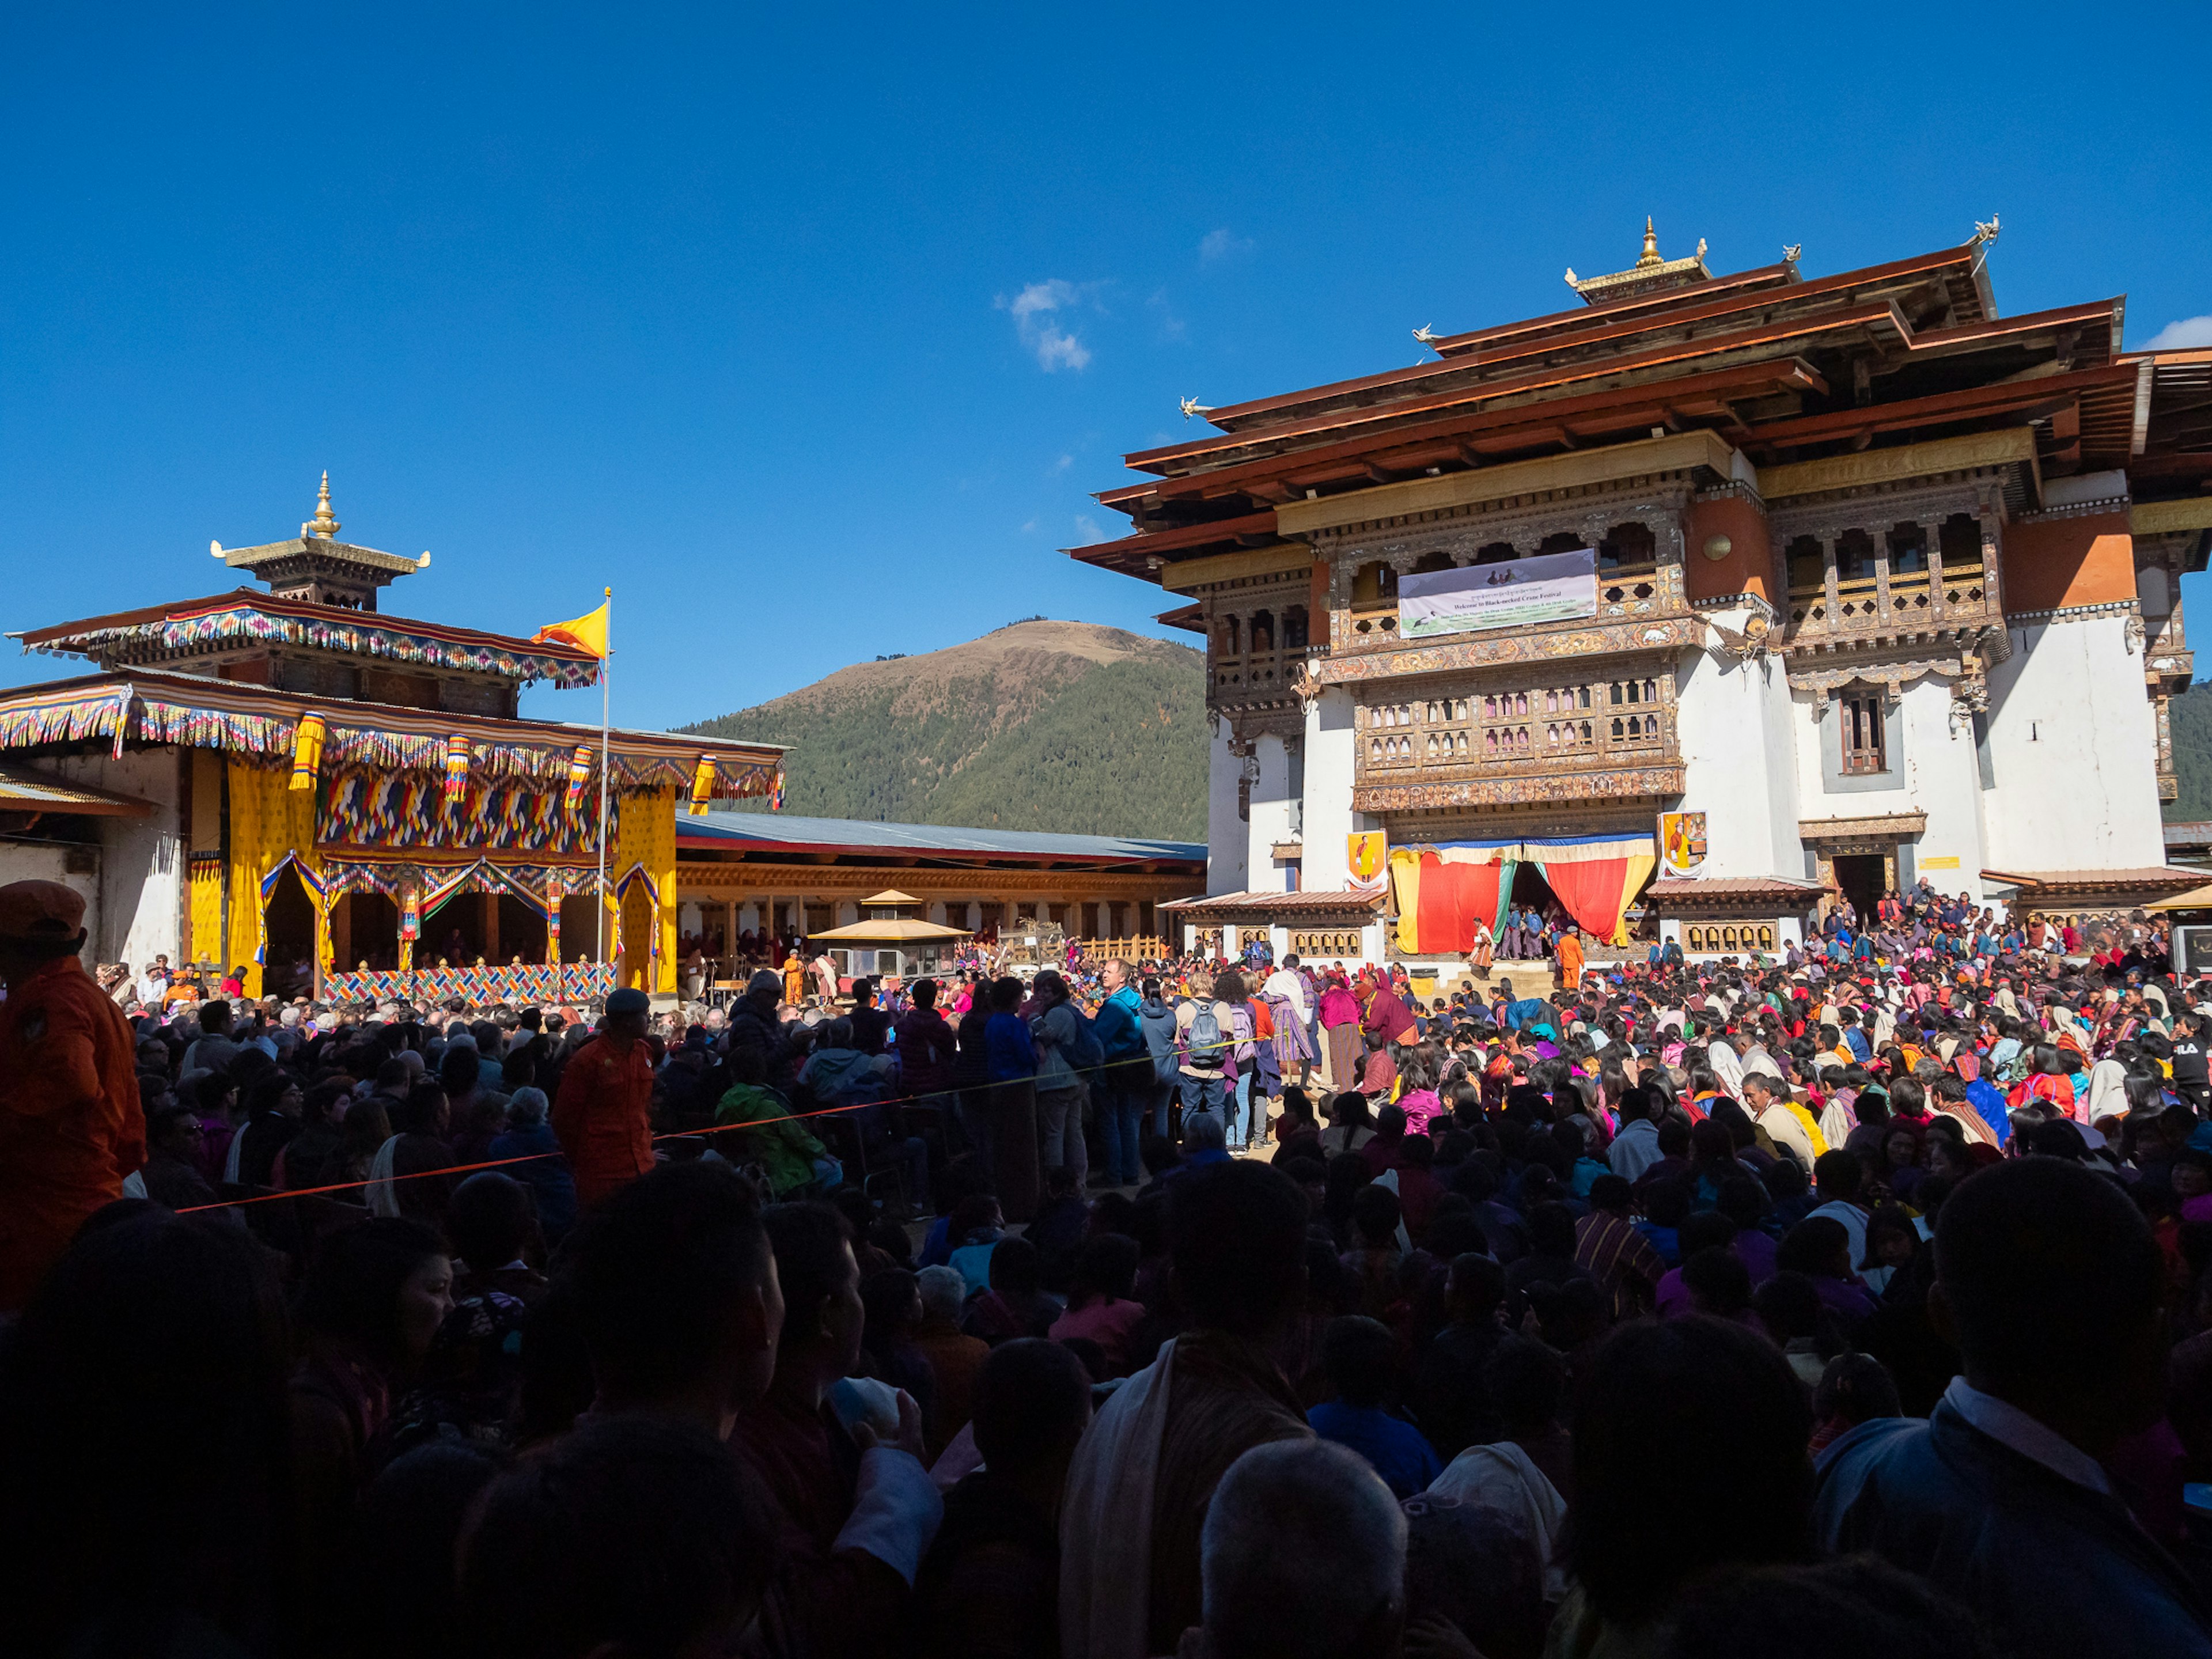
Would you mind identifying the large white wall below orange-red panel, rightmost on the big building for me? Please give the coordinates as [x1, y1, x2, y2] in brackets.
[1988, 615, 2165, 872]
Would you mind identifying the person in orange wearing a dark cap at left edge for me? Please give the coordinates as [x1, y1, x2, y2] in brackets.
[0, 880, 146, 1312]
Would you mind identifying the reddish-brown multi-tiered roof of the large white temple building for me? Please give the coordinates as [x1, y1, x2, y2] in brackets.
[1069, 224, 2212, 579]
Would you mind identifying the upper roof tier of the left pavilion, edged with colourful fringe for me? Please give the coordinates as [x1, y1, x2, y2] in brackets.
[18, 588, 600, 685]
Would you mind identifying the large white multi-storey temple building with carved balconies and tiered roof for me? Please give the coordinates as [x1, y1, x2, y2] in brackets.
[1071, 221, 2212, 960]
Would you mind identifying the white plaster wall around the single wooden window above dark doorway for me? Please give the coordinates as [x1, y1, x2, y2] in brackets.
[1785, 675, 1993, 898]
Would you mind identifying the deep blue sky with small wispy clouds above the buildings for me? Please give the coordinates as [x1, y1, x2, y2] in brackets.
[0, 5, 2212, 726]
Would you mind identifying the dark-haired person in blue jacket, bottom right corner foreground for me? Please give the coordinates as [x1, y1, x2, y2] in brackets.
[1814, 1157, 2212, 1659]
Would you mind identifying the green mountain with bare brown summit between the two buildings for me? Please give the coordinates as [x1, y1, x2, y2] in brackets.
[681, 619, 1206, 840]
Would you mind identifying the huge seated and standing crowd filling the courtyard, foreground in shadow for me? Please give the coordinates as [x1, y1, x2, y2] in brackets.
[0, 882, 2212, 1659]
